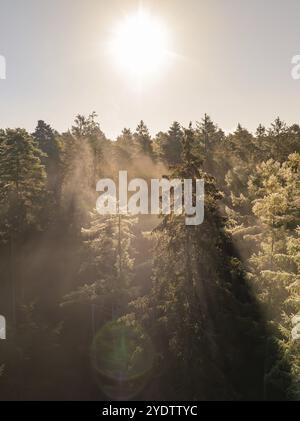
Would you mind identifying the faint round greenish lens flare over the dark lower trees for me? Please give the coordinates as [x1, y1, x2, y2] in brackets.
[91, 321, 154, 400]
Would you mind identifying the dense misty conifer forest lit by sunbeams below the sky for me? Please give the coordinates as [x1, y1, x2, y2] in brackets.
[0, 113, 300, 401]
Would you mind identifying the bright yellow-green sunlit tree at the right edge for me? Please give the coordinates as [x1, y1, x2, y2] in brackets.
[237, 154, 300, 399]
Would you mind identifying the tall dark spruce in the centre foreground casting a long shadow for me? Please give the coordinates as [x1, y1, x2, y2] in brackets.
[128, 125, 262, 399]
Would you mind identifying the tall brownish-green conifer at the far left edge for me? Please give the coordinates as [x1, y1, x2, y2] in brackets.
[0, 129, 46, 325]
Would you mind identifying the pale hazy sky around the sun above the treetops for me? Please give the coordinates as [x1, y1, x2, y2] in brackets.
[0, 0, 300, 138]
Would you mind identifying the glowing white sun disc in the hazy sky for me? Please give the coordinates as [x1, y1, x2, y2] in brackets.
[111, 10, 168, 79]
